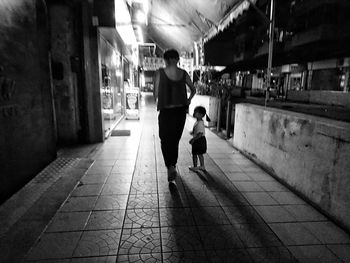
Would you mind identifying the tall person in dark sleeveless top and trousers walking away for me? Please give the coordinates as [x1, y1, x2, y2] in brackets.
[154, 49, 196, 183]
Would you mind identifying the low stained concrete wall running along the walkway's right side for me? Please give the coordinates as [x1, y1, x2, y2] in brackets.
[233, 104, 350, 229]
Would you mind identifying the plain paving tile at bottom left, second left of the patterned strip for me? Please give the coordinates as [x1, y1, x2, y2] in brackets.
[26, 232, 81, 260]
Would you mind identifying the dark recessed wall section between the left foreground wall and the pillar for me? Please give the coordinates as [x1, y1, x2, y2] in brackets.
[48, 2, 81, 144]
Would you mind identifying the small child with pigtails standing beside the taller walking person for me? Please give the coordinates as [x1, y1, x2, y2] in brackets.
[189, 106, 210, 172]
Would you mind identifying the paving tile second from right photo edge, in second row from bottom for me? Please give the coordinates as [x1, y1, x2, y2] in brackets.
[269, 223, 320, 246]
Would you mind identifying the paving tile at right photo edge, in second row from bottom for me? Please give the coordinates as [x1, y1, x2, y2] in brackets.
[302, 221, 350, 244]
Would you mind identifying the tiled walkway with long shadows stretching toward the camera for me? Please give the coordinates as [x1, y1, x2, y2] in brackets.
[0, 96, 350, 263]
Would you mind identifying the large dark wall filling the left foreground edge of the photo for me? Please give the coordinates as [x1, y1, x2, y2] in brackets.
[0, 0, 56, 202]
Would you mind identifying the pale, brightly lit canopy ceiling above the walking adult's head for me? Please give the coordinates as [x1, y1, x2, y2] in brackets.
[144, 0, 243, 52]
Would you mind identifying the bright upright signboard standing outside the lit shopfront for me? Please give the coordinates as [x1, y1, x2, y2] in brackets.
[125, 87, 140, 120]
